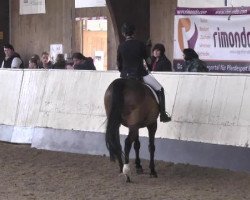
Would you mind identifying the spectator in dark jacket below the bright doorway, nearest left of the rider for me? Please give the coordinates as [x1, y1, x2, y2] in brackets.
[72, 52, 96, 70]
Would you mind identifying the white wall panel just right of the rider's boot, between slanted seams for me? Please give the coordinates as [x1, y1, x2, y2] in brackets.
[173, 74, 217, 123]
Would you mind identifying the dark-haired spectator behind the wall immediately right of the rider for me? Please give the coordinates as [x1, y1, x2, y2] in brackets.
[149, 43, 172, 71]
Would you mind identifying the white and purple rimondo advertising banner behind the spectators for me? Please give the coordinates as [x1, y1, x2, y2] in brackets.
[174, 7, 250, 73]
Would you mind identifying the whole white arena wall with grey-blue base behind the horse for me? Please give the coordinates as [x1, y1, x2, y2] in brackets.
[0, 69, 250, 171]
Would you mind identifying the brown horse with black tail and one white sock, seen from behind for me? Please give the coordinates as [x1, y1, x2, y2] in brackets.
[104, 78, 159, 182]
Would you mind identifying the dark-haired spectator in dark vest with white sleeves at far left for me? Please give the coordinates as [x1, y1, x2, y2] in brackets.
[1, 44, 24, 68]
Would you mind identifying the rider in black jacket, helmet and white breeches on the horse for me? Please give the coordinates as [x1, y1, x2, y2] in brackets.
[117, 23, 171, 122]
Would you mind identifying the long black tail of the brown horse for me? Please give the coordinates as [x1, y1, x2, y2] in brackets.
[105, 79, 125, 161]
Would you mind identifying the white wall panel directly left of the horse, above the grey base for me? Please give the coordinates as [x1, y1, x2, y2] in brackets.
[37, 71, 117, 132]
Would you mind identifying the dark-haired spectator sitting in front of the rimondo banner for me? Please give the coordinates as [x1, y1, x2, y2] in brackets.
[182, 48, 208, 72]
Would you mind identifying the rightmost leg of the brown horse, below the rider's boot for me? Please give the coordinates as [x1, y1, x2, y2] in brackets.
[147, 121, 157, 177]
